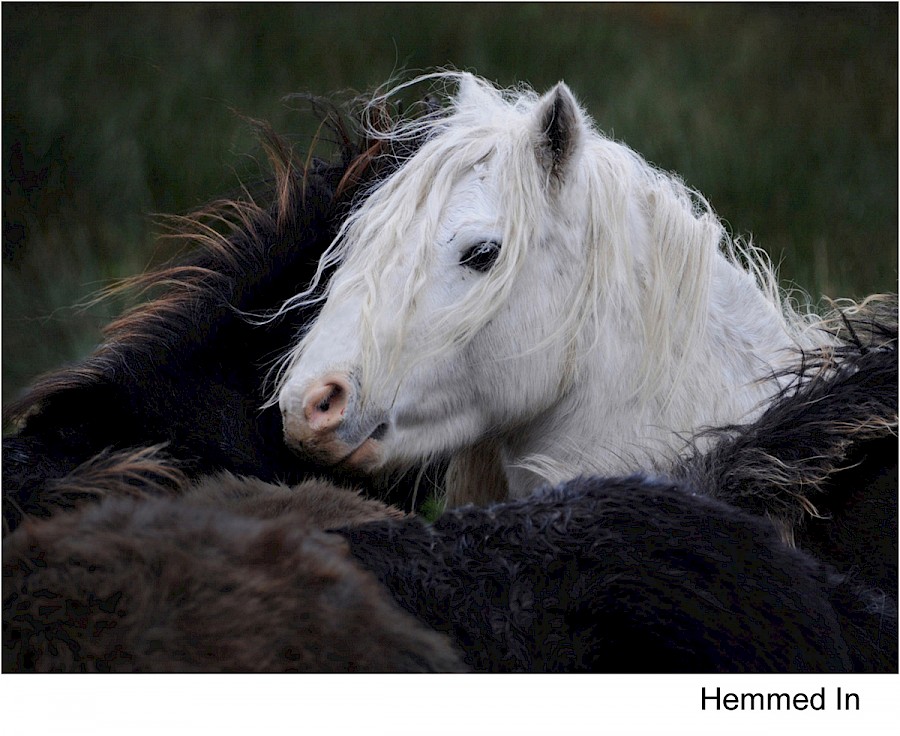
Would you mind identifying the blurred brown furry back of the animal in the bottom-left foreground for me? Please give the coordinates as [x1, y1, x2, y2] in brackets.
[3, 498, 463, 672]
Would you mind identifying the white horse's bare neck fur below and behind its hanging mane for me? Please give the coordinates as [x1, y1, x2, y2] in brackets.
[500, 254, 803, 497]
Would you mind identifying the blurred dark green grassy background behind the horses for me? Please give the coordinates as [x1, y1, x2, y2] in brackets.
[2, 3, 897, 401]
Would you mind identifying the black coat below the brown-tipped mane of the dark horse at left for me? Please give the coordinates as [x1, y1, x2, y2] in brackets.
[3, 161, 343, 527]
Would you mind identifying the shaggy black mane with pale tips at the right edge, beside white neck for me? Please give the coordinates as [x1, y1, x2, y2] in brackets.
[672, 297, 898, 600]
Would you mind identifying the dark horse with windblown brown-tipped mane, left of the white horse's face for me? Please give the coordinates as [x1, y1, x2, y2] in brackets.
[3, 110, 426, 530]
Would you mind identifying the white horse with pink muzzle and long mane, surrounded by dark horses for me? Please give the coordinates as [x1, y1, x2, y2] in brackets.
[273, 73, 827, 504]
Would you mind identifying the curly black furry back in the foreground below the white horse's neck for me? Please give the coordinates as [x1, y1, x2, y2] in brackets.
[340, 478, 897, 673]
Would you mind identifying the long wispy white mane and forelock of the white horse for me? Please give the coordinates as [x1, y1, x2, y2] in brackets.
[268, 72, 813, 414]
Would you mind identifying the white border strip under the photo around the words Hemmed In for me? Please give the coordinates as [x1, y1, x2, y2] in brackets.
[0, 674, 900, 736]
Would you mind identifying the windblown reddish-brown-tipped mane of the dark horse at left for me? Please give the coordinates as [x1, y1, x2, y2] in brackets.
[4, 108, 382, 423]
